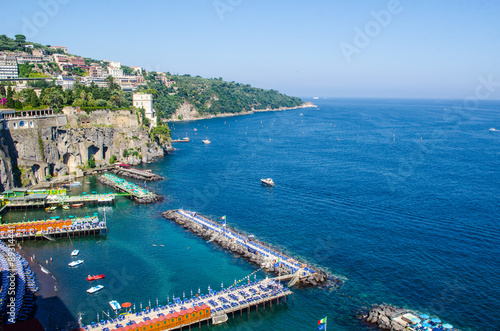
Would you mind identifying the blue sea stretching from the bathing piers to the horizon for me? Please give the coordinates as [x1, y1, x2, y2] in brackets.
[3, 98, 500, 331]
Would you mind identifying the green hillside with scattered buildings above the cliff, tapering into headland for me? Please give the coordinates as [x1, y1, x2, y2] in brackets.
[0, 35, 303, 123]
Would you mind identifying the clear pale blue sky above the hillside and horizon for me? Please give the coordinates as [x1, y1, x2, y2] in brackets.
[0, 0, 500, 99]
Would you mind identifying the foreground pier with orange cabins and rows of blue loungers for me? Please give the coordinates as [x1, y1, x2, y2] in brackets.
[83, 279, 293, 331]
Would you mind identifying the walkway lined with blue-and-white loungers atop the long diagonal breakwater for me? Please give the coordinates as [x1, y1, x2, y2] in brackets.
[177, 209, 315, 279]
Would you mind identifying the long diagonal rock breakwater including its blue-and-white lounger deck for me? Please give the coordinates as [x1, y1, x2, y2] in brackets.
[162, 210, 342, 287]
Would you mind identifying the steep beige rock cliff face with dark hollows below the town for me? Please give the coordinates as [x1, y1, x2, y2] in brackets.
[0, 108, 171, 189]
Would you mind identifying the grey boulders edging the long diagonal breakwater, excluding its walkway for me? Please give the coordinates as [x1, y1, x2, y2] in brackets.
[162, 210, 342, 287]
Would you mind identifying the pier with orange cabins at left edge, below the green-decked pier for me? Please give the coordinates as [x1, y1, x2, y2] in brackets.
[0, 215, 108, 241]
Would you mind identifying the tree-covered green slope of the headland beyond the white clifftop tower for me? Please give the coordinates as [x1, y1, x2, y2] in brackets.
[145, 72, 302, 118]
